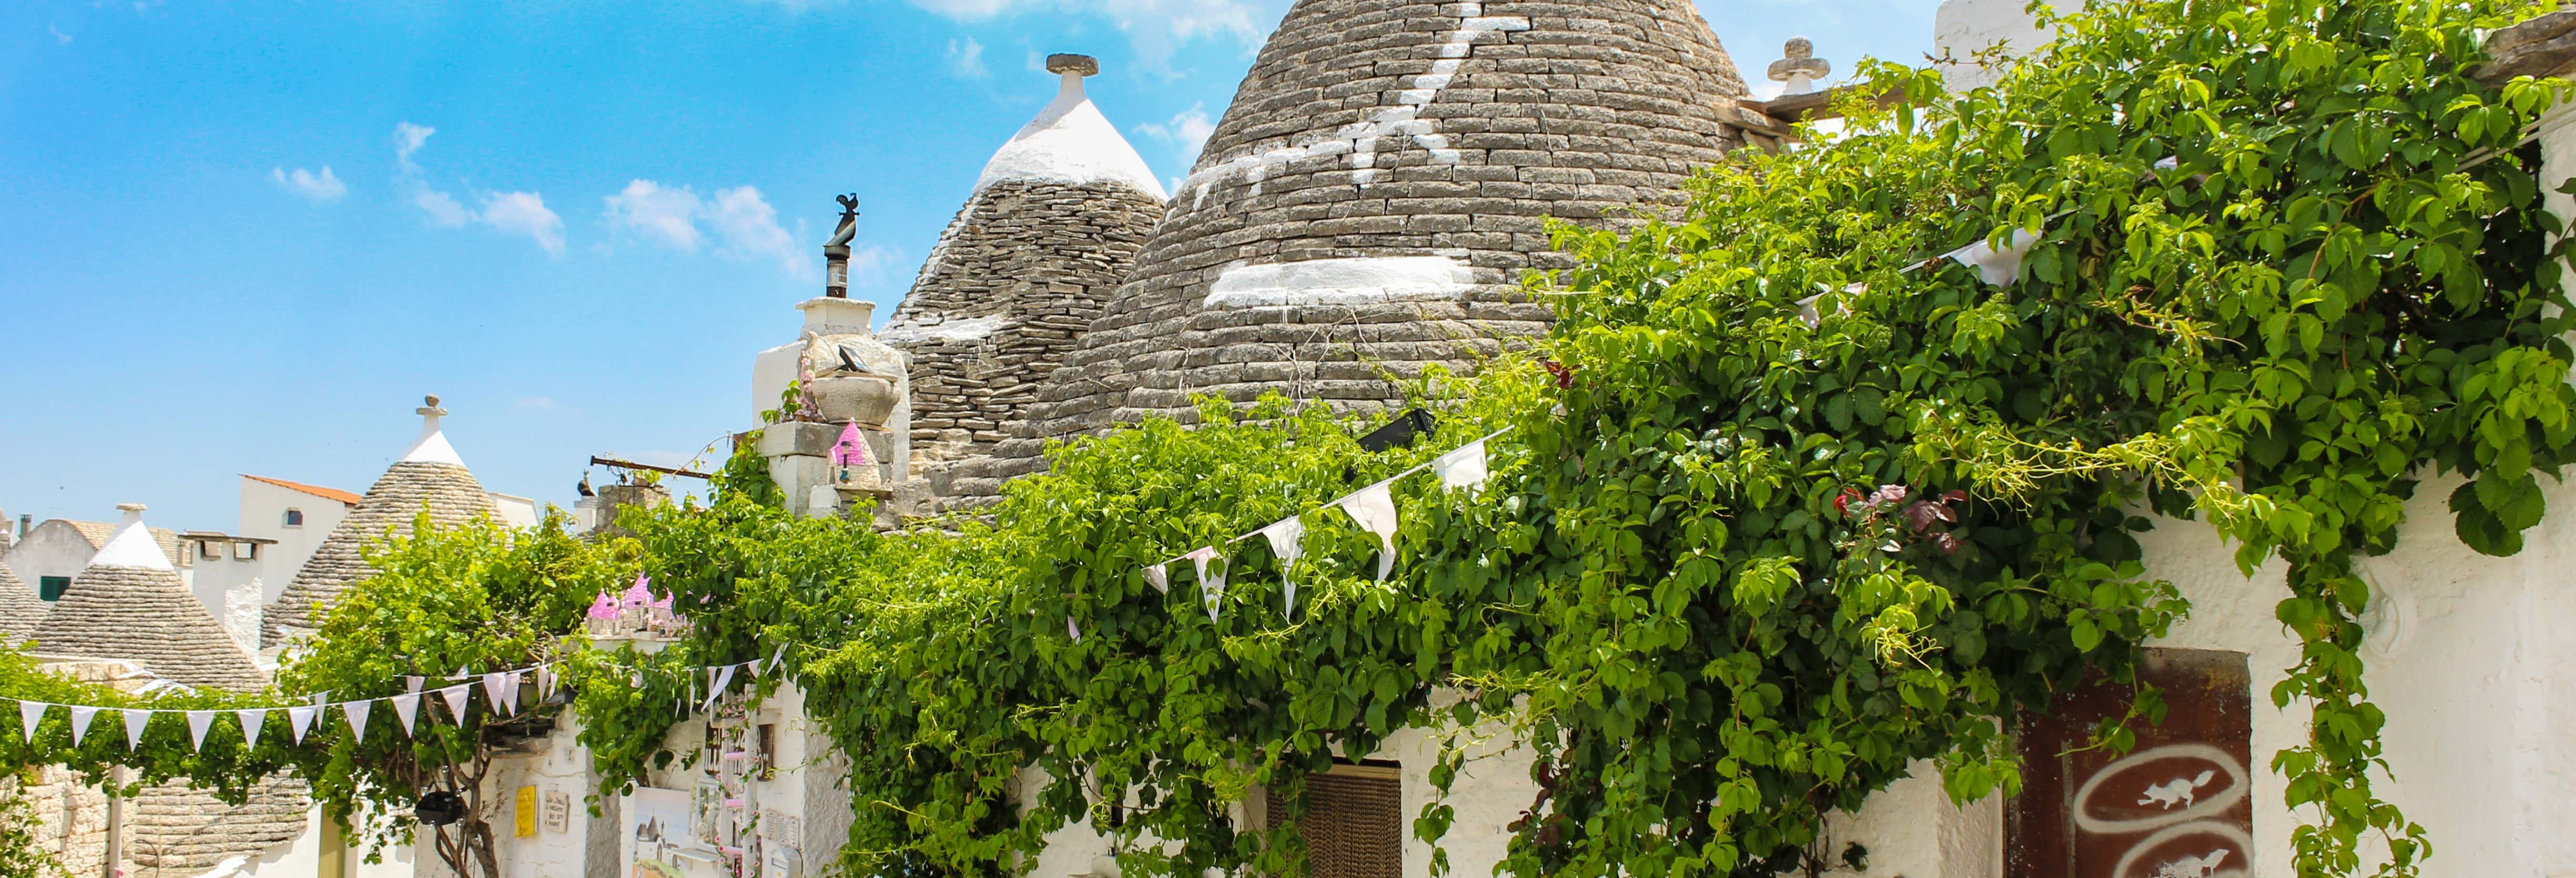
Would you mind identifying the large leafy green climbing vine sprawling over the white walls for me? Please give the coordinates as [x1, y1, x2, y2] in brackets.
[0, 0, 2576, 875]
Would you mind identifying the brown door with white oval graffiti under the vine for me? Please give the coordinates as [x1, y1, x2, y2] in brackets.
[2004, 649, 2254, 878]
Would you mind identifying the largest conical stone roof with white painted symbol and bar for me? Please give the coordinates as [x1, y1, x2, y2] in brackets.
[1002, 0, 1749, 451]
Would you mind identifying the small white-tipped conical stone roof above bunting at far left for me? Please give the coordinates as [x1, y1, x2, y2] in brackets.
[36, 505, 268, 692]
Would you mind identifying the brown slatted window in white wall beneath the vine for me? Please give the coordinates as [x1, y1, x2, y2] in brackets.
[1265, 762, 1404, 878]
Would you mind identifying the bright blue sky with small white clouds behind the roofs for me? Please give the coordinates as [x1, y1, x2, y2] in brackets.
[0, 0, 1937, 530]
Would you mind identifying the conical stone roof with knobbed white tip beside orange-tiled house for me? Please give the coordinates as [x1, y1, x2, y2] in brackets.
[260, 396, 500, 649]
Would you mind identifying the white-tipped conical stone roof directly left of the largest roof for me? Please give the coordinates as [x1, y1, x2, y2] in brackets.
[878, 54, 1164, 492]
